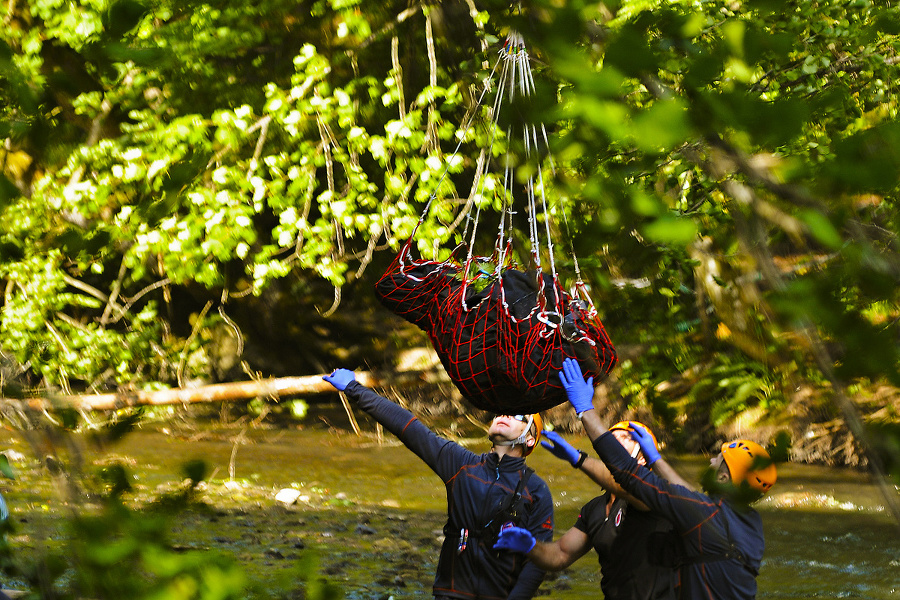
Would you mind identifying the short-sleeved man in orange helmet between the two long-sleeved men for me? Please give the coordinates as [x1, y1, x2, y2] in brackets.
[495, 421, 675, 600]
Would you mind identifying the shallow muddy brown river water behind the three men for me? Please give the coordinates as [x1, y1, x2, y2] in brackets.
[0, 418, 900, 600]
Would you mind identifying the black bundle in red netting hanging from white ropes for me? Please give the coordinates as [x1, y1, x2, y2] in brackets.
[375, 34, 617, 414]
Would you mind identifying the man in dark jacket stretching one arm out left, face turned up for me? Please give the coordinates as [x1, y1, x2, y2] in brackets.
[323, 369, 553, 600]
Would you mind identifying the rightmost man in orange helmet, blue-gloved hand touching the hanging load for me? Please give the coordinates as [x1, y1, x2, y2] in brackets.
[560, 360, 777, 600]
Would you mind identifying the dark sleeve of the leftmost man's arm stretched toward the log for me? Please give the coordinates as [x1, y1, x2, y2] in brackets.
[344, 381, 475, 483]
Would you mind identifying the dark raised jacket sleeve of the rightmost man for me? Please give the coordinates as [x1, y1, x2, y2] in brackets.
[594, 432, 719, 532]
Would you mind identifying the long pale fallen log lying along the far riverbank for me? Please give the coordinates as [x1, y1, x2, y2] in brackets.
[0, 371, 384, 411]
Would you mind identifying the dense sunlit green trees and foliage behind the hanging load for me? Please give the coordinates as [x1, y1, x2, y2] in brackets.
[0, 0, 900, 478]
